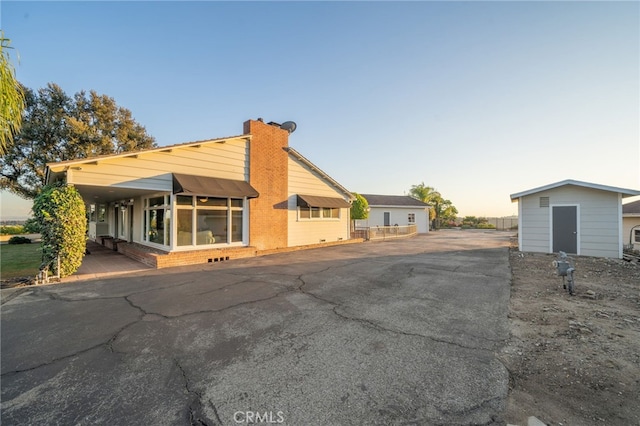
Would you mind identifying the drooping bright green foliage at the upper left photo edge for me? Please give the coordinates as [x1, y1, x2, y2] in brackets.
[0, 31, 25, 155]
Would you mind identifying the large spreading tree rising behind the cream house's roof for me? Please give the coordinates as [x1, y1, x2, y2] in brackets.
[0, 83, 156, 199]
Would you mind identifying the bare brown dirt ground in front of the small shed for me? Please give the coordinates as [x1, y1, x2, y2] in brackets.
[500, 248, 640, 426]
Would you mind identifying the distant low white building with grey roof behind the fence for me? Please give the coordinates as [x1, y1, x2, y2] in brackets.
[357, 194, 430, 233]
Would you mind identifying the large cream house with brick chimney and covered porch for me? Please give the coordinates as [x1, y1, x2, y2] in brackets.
[46, 119, 353, 268]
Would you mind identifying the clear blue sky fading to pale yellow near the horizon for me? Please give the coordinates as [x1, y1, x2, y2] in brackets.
[0, 0, 640, 219]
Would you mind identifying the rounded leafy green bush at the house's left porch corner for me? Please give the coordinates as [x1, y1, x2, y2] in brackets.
[33, 183, 87, 277]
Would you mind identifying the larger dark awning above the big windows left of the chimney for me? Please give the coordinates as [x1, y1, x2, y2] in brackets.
[173, 173, 259, 198]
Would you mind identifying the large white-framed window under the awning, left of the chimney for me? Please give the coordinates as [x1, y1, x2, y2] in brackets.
[176, 195, 244, 246]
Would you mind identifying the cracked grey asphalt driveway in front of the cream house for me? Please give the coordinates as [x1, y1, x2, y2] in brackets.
[0, 231, 511, 425]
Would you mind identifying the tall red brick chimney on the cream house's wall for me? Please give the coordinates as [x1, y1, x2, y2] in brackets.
[244, 120, 289, 250]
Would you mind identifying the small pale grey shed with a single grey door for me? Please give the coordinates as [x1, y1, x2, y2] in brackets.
[511, 180, 640, 258]
